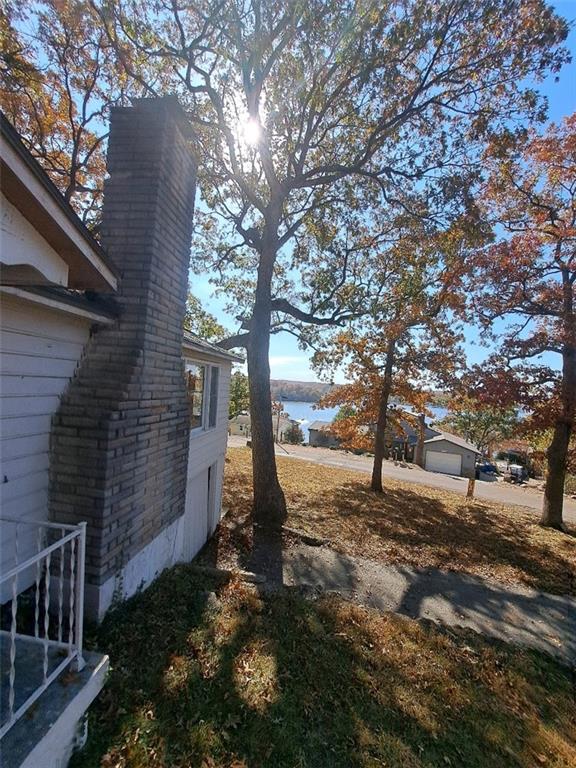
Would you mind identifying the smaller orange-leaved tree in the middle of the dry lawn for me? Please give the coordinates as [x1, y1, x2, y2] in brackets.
[314, 213, 476, 492]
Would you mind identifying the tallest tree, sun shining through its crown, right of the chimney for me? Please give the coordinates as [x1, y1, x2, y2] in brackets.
[19, 0, 567, 527]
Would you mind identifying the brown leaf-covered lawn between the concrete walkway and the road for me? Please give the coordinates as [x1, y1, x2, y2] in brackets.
[213, 448, 576, 595]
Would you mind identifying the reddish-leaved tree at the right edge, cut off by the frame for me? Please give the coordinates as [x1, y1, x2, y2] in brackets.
[471, 114, 576, 528]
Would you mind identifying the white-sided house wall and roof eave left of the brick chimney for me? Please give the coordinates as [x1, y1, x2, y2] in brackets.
[0, 119, 117, 602]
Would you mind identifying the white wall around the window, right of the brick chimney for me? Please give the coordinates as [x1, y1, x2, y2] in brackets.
[183, 352, 231, 560]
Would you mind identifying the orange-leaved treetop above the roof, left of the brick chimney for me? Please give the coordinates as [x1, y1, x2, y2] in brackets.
[0, 0, 130, 221]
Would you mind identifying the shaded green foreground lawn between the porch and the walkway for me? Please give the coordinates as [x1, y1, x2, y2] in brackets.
[74, 568, 570, 768]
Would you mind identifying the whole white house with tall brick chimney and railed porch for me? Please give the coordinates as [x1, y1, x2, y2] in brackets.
[0, 98, 239, 768]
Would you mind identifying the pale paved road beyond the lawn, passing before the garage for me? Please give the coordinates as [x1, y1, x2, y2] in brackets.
[228, 437, 576, 523]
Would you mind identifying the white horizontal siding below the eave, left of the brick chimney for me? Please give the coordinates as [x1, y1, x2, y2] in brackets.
[0, 295, 90, 601]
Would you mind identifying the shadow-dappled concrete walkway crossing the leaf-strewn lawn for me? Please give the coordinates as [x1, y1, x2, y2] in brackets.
[283, 544, 576, 664]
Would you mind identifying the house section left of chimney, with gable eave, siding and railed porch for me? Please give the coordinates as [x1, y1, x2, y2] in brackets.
[0, 111, 117, 768]
